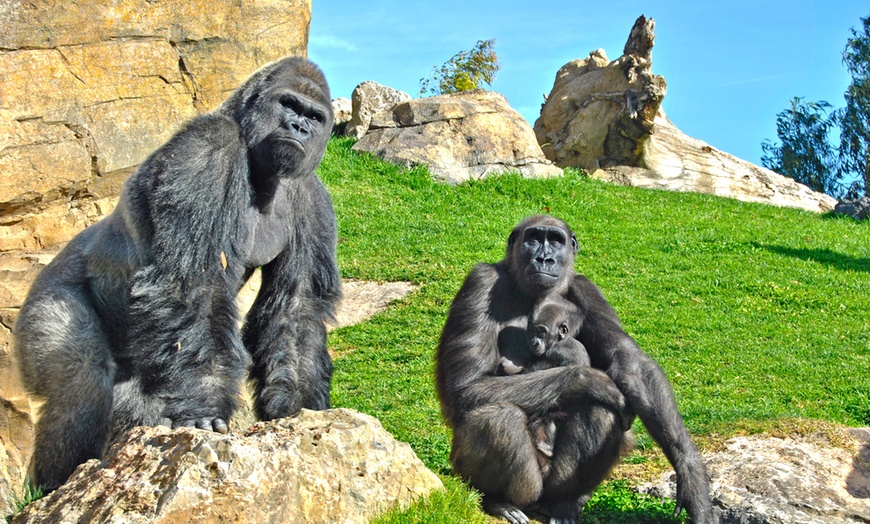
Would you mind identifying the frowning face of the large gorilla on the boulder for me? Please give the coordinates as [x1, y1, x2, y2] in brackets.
[246, 68, 333, 178]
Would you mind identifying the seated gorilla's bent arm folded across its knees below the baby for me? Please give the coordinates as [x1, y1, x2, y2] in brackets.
[436, 264, 625, 421]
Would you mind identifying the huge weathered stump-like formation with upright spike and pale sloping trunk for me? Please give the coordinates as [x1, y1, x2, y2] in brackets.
[535, 16, 836, 212]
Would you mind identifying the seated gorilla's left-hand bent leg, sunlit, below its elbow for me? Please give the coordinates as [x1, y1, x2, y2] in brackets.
[450, 402, 542, 523]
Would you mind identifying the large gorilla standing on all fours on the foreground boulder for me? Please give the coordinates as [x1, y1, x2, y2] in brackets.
[15, 57, 341, 490]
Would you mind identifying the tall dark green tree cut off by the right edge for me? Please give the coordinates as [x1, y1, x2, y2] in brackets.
[837, 16, 870, 196]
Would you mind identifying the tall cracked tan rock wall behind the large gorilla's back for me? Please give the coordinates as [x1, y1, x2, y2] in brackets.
[0, 0, 311, 251]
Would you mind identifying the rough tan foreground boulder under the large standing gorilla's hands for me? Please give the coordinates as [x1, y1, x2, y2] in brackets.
[12, 409, 442, 524]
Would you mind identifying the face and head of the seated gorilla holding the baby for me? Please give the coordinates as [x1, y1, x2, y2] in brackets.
[516, 225, 576, 291]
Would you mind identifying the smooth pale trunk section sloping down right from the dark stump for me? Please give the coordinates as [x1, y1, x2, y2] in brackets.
[591, 111, 837, 212]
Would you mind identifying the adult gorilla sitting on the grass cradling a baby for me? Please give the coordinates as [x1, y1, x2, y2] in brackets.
[435, 216, 716, 524]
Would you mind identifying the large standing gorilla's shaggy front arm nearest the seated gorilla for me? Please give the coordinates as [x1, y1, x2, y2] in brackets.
[242, 178, 341, 420]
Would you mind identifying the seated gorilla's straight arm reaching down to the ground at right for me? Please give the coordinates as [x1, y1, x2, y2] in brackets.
[568, 275, 716, 523]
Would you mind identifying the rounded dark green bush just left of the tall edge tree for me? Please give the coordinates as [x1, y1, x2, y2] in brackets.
[761, 97, 841, 195]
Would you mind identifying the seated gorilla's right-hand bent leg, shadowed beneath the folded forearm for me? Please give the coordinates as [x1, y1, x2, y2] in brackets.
[540, 404, 634, 523]
